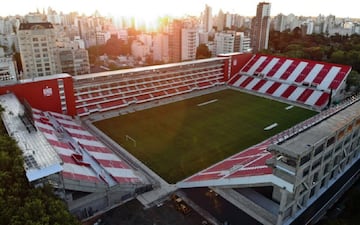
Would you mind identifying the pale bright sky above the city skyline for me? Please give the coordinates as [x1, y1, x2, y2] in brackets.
[0, 0, 360, 19]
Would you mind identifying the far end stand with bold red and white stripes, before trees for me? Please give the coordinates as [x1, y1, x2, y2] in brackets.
[229, 54, 351, 108]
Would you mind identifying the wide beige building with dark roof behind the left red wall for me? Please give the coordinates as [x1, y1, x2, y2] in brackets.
[18, 22, 61, 79]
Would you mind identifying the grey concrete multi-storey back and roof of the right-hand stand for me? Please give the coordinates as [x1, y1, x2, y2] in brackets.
[268, 102, 360, 224]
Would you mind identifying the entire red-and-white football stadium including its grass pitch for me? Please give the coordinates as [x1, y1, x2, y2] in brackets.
[0, 53, 360, 224]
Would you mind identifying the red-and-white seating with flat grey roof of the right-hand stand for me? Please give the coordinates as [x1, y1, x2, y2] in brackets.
[177, 97, 360, 192]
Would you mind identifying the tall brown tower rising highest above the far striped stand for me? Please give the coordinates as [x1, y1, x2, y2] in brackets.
[251, 2, 271, 52]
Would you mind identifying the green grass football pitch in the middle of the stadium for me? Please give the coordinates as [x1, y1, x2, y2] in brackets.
[94, 89, 317, 183]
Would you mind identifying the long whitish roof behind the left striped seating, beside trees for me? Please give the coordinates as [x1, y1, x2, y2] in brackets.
[0, 93, 63, 182]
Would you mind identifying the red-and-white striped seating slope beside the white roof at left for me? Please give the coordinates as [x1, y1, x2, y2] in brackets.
[33, 109, 143, 187]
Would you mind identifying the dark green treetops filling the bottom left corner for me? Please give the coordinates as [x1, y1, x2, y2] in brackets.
[0, 118, 80, 225]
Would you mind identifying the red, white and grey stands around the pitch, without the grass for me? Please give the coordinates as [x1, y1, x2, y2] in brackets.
[0, 53, 360, 224]
